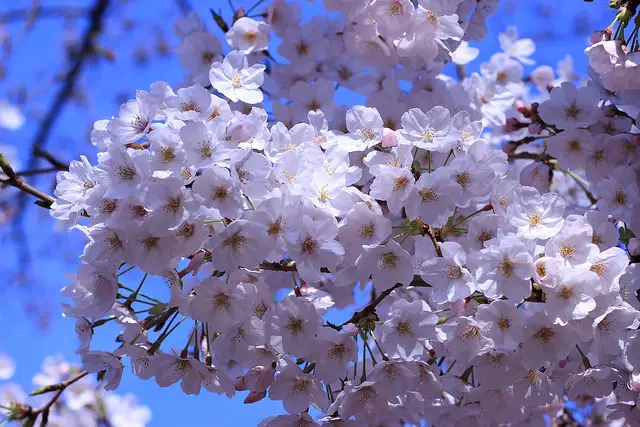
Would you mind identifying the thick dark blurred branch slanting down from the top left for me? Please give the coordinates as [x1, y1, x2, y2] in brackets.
[16, 0, 109, 219]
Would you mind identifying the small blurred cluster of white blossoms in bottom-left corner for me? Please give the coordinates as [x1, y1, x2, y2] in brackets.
[0, 352, 151, 427]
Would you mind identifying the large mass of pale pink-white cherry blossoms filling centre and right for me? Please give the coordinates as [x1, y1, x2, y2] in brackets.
[33, 0, 640, 427]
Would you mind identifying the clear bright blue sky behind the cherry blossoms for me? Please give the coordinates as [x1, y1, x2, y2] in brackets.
[0, 0, 613, 426]
